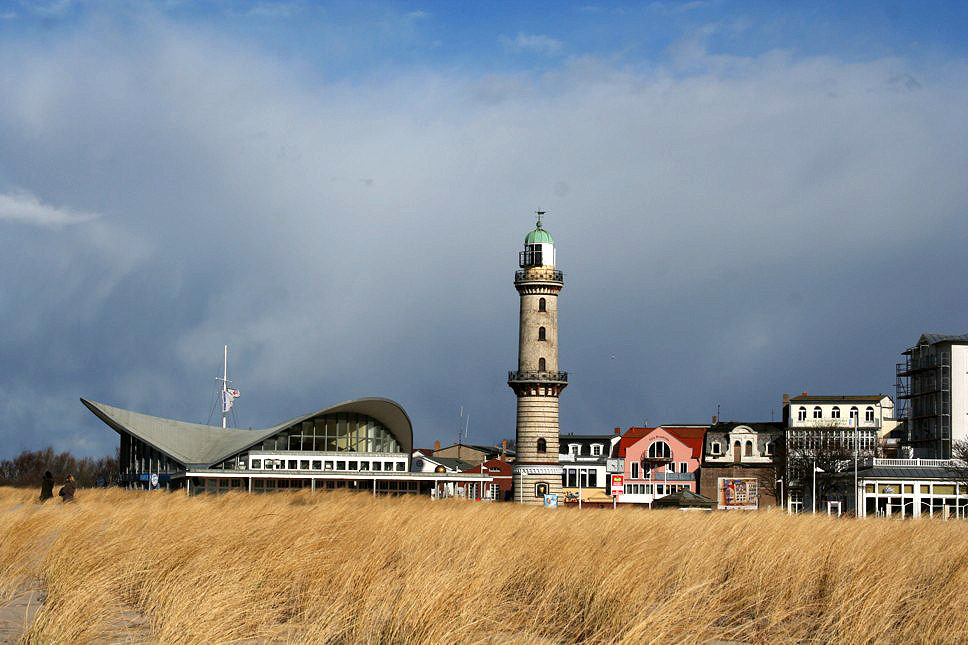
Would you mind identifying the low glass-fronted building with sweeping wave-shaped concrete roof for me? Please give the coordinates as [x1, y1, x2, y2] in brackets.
[81, 398, 490, 493]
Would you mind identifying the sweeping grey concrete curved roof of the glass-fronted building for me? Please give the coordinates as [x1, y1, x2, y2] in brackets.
[81, 398, 413, 466]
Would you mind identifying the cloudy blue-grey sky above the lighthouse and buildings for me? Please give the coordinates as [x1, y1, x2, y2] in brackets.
[0, 0, 968, 458]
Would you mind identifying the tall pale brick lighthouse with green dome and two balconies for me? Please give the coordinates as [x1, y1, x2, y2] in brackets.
[508, 211, 568, 504]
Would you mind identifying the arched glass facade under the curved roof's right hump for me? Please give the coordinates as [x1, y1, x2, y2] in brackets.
[262, 413, 402, 452]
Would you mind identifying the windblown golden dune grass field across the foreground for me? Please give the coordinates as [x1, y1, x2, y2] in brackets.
[0, 488, 968, 645]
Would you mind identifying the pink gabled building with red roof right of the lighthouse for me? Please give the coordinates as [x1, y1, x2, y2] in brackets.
[618, 426, 706, 504]
